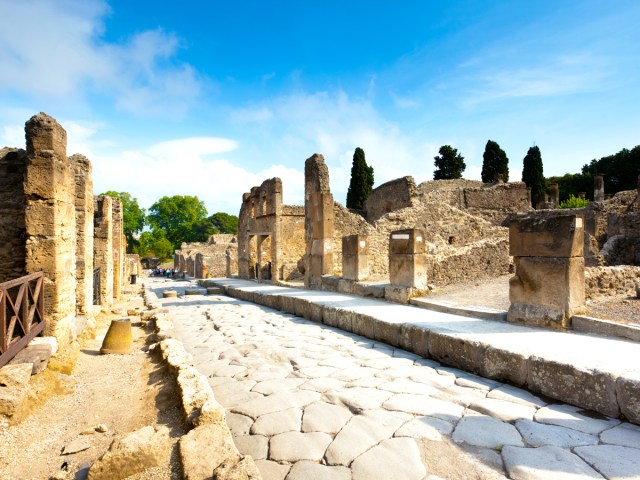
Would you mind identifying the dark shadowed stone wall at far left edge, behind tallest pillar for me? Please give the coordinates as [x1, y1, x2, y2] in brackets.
[0, 148, 27, 283]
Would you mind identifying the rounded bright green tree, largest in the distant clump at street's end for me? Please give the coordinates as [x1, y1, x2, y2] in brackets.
[147, 195, 207, 249]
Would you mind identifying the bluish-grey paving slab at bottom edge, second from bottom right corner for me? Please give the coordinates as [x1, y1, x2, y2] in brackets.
[502, 445, 602, 480]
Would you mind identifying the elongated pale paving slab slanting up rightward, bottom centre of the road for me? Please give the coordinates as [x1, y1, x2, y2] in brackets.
[325, 410, 410, 467]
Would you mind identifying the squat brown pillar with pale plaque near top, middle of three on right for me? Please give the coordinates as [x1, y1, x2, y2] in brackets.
[389, 229, 427, 290]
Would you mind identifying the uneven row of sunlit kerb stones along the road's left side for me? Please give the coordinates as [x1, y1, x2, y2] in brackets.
[143, 288, 261, 480]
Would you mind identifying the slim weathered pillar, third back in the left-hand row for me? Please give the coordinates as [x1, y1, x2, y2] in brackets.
[93, 196, 113, 312]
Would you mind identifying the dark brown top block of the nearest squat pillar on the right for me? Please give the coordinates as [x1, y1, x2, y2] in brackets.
[509, 214, 584, 258]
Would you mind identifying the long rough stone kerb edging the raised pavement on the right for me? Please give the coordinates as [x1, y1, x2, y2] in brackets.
[207, 280, 640, 424]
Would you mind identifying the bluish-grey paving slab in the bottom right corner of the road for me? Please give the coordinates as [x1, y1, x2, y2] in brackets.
[573, 445, 640, 480]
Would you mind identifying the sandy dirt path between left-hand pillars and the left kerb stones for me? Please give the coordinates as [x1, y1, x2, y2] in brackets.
[0, 288, 183, 480]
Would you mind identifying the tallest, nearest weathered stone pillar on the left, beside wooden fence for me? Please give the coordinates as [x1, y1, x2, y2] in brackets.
[24, 113, 76, 345]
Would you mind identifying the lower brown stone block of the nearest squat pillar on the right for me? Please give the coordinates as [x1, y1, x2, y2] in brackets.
[507, 257, 585, 328]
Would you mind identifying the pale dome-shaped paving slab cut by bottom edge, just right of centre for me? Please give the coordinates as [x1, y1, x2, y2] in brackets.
[351, 438, 427, 480]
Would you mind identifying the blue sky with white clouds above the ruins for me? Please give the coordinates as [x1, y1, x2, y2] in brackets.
[0, 0, 640, 214]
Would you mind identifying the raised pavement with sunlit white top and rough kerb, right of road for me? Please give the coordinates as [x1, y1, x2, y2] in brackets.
[203, 278, 640, 424]
